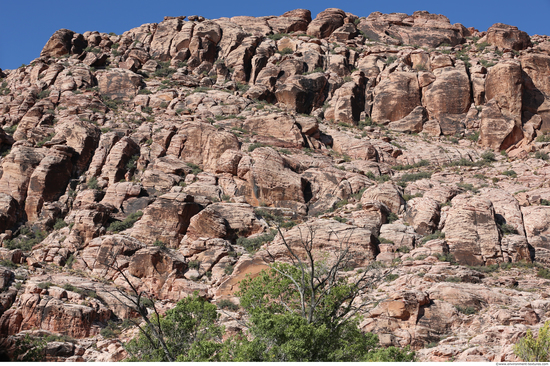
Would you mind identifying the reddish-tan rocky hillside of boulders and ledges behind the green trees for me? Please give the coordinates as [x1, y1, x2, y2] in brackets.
[0, 9, 550, 362]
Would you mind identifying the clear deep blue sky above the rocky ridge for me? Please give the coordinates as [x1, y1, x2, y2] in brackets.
[0, 0, 550, 70]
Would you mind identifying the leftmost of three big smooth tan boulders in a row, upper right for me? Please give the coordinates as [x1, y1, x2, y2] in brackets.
[371, 72, 420, 123]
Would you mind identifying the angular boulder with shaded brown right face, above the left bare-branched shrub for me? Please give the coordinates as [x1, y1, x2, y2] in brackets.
[131, 192, 201, 247]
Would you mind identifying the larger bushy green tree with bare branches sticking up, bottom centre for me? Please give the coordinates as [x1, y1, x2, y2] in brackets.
[220, 227, 414, 362]
